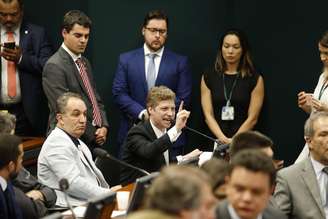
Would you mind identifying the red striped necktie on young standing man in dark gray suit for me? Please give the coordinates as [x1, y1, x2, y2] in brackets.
[75, 58, 102, 127]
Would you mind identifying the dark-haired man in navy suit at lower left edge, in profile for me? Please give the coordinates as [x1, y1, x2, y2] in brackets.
[0, 134, 24, 219]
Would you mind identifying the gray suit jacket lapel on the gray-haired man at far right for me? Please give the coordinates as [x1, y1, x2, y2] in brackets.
[301, 158, 325, 217]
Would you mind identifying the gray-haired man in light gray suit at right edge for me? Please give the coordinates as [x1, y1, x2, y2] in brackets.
[274, 111, 328, 219]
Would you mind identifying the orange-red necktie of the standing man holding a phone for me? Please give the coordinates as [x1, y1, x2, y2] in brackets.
[7, 32, 16, 97]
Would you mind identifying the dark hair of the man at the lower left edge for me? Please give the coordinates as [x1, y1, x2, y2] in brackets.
[0, 134, 22, 169]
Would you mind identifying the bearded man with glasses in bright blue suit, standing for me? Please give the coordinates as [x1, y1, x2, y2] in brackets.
[112, 10, 192, 158]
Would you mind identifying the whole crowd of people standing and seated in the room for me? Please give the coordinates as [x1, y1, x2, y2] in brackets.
[0, 0, 328, 219]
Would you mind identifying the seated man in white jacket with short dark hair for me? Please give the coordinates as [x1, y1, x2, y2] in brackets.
[38, 93, 110, 206]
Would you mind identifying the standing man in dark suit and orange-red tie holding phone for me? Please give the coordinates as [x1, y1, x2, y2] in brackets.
[0, 0, 53, 136]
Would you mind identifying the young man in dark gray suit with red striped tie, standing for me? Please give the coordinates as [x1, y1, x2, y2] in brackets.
[43, 10, 108, 148]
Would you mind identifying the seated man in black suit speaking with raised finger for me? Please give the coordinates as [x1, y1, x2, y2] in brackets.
[121, 86, 201, 184]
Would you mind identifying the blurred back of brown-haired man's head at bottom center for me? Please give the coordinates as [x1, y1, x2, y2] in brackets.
[128, 165, 216, 219]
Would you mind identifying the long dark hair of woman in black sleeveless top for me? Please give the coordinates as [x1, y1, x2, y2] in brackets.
[215, 29, 255, 77]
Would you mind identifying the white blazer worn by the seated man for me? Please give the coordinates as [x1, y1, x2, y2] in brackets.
[38, 127, 109, 206]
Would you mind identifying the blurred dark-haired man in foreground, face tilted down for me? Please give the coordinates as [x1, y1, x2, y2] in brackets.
[216, 149, 287, 219]
